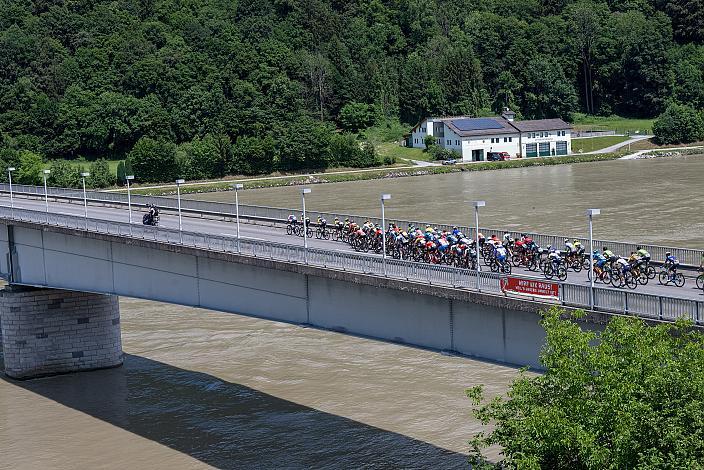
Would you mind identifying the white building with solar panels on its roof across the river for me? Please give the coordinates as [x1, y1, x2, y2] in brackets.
[406, 110, 572, 162]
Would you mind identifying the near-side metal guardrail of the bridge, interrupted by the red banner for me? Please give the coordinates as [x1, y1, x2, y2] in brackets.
[0, 207, 704, 324]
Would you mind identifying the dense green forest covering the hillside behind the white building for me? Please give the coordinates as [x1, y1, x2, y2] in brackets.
[0, 0, 704, 185]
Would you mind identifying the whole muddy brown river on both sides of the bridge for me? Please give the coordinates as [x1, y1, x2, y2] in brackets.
[0, 156, 704, 469]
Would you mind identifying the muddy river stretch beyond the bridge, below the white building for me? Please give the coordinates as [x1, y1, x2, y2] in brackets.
[187, 155, 704, 249]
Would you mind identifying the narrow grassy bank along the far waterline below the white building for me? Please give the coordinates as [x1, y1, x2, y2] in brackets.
[126, 153, 623, 196]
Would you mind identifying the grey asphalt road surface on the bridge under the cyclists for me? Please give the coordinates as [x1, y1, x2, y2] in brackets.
[0, 196, 704, 301]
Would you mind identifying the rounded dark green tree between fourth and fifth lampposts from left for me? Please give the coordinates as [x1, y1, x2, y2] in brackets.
[129, 137, 180, 183]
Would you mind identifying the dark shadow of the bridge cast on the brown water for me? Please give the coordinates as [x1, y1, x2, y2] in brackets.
[0, 353, 467, 468]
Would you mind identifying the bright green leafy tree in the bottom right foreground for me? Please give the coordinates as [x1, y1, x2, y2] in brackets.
[467, 308, 704, 469]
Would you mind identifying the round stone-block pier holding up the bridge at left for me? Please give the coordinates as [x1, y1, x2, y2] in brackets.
[0, 286, 122, 379]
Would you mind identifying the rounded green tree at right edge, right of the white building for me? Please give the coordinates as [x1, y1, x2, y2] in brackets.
[653, 103, 704, 144]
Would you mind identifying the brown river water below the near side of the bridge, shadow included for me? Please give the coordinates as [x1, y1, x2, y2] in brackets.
[0, 299, 517, 469]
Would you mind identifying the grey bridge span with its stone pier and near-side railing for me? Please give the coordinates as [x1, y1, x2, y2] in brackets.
[0, 193, 704, 378]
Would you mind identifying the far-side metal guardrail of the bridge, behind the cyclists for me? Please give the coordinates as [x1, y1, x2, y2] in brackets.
[0, 183, 704, 267]
